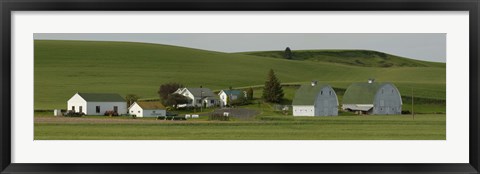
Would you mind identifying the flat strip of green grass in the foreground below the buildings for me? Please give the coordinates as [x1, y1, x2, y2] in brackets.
[34, 114, 446, 140]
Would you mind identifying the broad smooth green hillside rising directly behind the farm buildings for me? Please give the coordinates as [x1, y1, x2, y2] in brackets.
[34, 40, 446, 109]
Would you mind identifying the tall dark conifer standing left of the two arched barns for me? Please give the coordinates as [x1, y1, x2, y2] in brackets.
[262, 69, 284, 103]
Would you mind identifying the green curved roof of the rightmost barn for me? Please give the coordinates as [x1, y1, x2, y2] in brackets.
[342, 82, 390, 104]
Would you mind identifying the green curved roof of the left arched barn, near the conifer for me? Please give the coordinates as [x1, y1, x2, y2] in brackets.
[292, 83, 329, 105]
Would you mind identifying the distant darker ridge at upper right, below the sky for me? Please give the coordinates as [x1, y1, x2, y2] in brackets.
[238, 50, 445, 67]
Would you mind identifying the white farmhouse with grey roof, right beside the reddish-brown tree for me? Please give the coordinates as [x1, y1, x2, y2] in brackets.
[173, 88, 219, 107]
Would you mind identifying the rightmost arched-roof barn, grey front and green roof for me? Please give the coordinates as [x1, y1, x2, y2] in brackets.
[342, 79, 402, 115]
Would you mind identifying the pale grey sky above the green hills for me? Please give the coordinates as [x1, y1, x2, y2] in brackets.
[33, 33, 446, 62]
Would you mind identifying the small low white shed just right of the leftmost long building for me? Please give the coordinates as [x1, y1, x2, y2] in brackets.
[128, 101, 167, 117]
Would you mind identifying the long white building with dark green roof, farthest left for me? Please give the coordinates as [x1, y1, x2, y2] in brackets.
[67, 92, 127, 115]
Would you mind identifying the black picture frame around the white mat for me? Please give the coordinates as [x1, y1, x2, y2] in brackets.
[0, 0, 480, 173]
